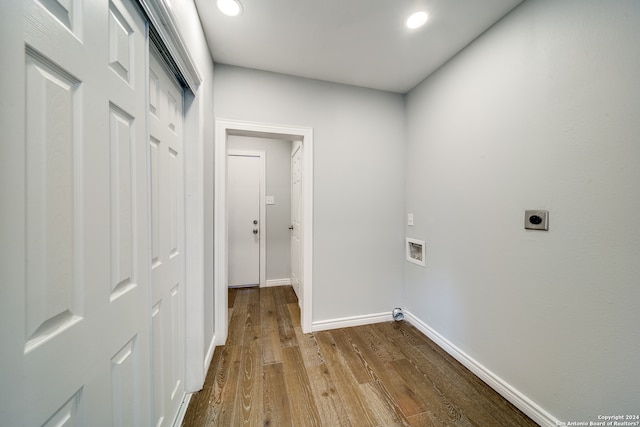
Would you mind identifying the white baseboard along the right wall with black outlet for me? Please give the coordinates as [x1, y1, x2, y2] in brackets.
[404, 311, 559, 427]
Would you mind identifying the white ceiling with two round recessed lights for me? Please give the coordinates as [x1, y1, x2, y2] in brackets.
[195, 0, 522, 93]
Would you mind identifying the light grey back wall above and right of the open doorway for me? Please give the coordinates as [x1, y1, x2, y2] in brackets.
[214, 64, 405, 322]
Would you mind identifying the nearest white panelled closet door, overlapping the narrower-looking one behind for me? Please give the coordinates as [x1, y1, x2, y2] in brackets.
[8, 0, 150, 426]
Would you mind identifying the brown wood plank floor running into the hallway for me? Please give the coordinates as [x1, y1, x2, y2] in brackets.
[183, 286, 536, 427]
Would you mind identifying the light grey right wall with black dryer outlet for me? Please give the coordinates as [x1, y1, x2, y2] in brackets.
[405, 0, 640, 421]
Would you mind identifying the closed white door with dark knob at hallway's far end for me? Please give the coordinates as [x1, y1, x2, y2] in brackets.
[227, 154, 262, 286]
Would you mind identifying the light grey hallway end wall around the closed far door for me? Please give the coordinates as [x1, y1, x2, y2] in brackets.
[227, 135, 291, 280]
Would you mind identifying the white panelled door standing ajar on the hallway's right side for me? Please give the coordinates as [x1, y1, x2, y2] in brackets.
[291, 141, 302, 302]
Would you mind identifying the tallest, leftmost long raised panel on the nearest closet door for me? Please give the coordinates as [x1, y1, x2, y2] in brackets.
[25, 50, 83, 353]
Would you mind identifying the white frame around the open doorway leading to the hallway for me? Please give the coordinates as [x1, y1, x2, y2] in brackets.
[213, 119, 313, 345]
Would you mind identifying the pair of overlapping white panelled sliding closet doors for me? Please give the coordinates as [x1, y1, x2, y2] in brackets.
[0, 0, 185, 426]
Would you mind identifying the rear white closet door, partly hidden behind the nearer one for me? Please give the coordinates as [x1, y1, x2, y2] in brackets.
[149, 49, 185, 426]
